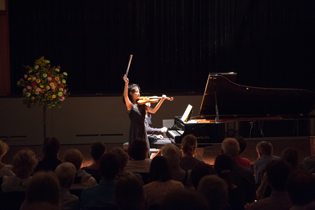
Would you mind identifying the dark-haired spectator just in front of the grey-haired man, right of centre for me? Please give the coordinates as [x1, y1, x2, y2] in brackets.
[214, 154, 247, 210]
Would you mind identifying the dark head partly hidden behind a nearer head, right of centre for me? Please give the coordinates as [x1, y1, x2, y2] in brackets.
[190, 162, 216, 190]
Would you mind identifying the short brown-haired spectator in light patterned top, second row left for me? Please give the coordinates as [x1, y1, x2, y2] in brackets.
[63, 149, 97, 189]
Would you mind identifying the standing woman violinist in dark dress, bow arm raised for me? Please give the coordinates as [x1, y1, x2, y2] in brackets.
[123, 74, 166, 148]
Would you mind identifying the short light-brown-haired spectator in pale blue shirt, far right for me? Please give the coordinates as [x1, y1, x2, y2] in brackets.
[254, 141, 279, 187]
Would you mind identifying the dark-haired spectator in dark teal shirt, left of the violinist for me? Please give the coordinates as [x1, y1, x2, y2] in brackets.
[81, 152, 120, 210]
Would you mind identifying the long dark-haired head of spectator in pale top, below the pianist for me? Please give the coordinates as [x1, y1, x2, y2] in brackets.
[149, 156, 172, 182]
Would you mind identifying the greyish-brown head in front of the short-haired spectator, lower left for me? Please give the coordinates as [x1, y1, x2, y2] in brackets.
[55, 162, 77, 189]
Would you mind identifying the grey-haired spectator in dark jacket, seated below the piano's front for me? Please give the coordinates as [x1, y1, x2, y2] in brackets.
[221, 138, 256, 203]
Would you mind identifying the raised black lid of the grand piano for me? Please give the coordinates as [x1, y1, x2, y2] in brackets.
[199, 72, 315, 117]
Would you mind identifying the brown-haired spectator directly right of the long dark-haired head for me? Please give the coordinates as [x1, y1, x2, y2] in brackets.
[162, 143, 192, 188]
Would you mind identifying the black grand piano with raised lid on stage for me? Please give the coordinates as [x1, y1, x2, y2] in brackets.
[166, 72, 315, 146]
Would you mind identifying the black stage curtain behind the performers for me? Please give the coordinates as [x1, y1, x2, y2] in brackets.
[8, 0, 315, 95]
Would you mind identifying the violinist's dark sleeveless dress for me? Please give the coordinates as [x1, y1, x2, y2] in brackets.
[129, 104, 150, 148]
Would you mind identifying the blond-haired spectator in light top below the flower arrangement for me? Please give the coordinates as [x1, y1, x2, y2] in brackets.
[1, 149, 37, 192]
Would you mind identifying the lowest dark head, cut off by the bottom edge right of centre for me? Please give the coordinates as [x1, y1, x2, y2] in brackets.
[161, 189, 209, 210]
